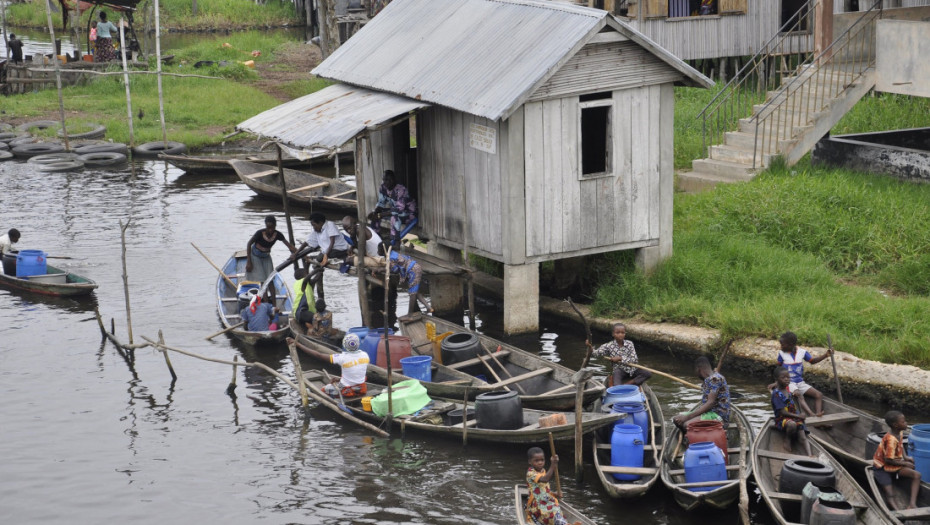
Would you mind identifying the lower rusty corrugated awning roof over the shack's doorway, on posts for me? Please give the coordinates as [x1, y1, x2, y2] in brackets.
[236, 84, 429, 151]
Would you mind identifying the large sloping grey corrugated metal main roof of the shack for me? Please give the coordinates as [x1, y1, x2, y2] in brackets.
[313, 0, 609, 120]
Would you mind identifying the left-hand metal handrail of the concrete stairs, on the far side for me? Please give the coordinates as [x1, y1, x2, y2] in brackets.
[695, 0, 820, 156]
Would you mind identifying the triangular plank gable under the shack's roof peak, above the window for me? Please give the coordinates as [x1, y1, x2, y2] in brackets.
[529, 41, 683, 101]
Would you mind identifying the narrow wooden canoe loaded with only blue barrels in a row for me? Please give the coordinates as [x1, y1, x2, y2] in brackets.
[594, 385, 665, 499]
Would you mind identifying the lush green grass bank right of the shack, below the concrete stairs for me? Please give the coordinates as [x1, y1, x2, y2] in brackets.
[594, 89, 930, 368]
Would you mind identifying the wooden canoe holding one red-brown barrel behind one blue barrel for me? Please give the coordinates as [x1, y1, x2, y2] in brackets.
[661, 405, 753, 511]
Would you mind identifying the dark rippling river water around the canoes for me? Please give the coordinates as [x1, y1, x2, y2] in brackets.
[0, 162, 916, 524]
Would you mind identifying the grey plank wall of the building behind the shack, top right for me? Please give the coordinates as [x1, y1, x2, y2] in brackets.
[627, 0, 812, 60]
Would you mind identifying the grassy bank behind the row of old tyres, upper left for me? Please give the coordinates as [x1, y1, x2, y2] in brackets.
[3, 32, 324, 148]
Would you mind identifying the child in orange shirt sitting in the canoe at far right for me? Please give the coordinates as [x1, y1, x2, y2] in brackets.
[872, 410, 920, 510]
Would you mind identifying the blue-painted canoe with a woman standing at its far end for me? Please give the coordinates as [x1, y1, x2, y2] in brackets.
[216, 250, 293, 345]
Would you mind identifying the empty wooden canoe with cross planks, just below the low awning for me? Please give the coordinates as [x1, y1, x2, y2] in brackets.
[229, 160, 358, 213]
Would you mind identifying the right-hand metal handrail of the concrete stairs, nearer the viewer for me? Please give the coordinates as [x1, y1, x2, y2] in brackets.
[749, 0, 883, 168]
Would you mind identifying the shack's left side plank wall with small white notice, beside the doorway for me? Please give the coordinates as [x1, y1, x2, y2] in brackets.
[417, 106, 506, 258]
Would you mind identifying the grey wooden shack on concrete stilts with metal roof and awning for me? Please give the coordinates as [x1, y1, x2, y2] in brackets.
[239, 0, 713, 333]
